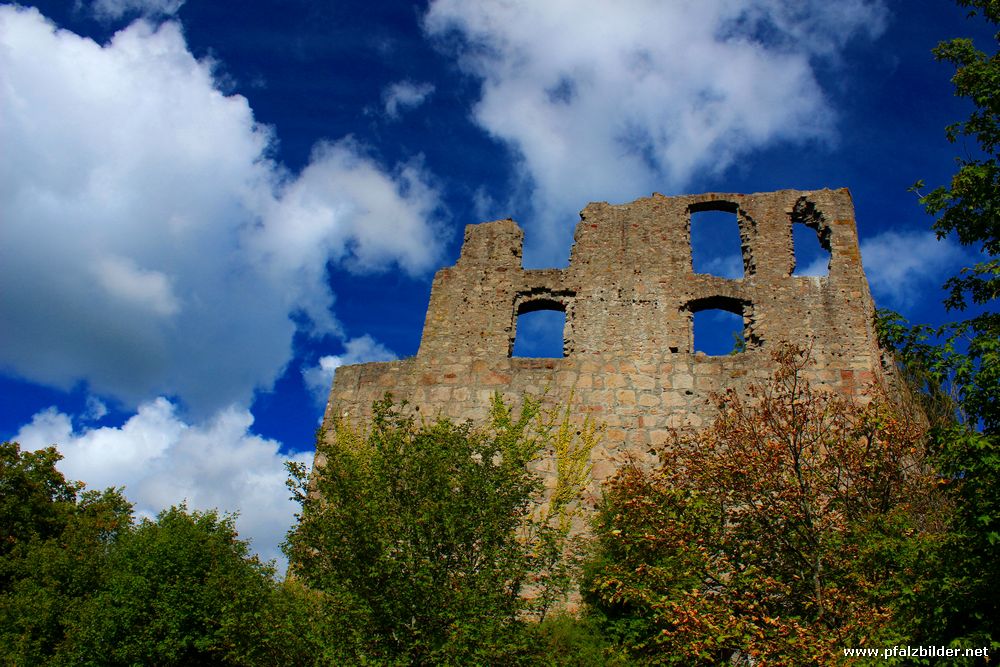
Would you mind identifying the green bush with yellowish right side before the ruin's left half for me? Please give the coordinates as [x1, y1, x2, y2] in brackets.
[286, 396, 596, 664]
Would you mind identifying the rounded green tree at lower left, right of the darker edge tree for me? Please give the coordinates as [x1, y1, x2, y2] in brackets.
[62, 506, 284, 665]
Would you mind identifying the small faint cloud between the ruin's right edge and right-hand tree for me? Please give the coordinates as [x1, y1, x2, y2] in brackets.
[861, 230, 969, 308]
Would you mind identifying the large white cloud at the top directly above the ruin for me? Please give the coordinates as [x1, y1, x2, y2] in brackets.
[424, 0, 885, 259]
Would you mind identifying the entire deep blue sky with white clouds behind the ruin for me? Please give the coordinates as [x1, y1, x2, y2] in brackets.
[0, 0, 991, 568]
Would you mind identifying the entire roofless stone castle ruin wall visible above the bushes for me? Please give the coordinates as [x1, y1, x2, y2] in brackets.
[317, 189, 881, 490]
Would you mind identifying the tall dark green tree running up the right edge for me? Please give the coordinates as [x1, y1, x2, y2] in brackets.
[880, 0, 1000, 646]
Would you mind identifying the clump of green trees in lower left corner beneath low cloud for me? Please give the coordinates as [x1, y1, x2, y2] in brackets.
[0, 443, 312, 666]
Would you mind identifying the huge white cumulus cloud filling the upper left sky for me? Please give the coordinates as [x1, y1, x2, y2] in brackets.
[0, 7, 440, 419]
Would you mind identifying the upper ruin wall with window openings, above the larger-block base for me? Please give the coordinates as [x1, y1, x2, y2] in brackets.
[418, 189, 873, 366]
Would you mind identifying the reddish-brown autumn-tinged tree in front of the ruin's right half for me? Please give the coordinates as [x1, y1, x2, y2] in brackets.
[584, 347, 949, 665]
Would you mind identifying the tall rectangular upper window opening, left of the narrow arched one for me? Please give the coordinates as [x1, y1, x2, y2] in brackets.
[691, 202, 743, 279]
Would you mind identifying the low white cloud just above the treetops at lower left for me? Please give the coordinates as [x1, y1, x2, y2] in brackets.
[14, 398, 312, 571]
